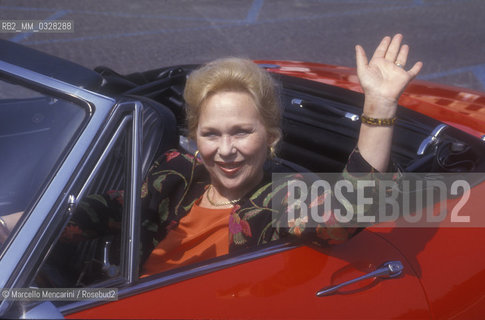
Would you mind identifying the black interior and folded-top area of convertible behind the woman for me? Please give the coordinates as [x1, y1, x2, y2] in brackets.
[96, 65, 485, 176]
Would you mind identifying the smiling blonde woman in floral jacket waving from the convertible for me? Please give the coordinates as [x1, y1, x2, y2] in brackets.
[138, 34, 422, 275]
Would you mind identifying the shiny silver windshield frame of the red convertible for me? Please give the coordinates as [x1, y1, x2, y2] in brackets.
[0, 61, 116, 315]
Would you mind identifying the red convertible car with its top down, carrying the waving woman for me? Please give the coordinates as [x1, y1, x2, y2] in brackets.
[0, 41, 485, 319]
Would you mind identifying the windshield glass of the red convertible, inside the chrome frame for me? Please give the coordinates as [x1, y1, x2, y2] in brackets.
[0, 80, 87, 244]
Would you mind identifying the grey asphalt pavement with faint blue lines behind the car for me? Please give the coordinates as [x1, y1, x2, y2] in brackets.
[0, 0, 485, 91]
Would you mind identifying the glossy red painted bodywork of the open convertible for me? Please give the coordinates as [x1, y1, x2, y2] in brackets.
[67, 61, 485, 319]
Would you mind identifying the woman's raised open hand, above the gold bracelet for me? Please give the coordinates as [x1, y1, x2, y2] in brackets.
[355, 34, 423, 118]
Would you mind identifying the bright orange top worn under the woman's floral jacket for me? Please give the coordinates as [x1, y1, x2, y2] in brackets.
[143, 201, 232, 276]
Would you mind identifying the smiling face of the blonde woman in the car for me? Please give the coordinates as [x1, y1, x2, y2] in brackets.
[196, 91, 271, 200]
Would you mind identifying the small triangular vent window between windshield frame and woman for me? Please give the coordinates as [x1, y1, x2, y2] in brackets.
[35, 119, 131, 288]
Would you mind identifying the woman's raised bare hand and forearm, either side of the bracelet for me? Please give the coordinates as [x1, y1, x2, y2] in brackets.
[355, 34, 423, 171]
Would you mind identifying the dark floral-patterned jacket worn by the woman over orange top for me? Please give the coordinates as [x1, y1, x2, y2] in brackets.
[63, 149, 392, 261]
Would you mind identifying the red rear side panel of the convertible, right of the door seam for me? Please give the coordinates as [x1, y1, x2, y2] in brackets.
[372, 183, 485, 319]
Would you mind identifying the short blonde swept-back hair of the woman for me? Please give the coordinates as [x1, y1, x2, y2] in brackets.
[184, 58, 281, 147]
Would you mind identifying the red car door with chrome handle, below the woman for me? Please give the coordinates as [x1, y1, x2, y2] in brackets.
[66, 226, 431, 319]
